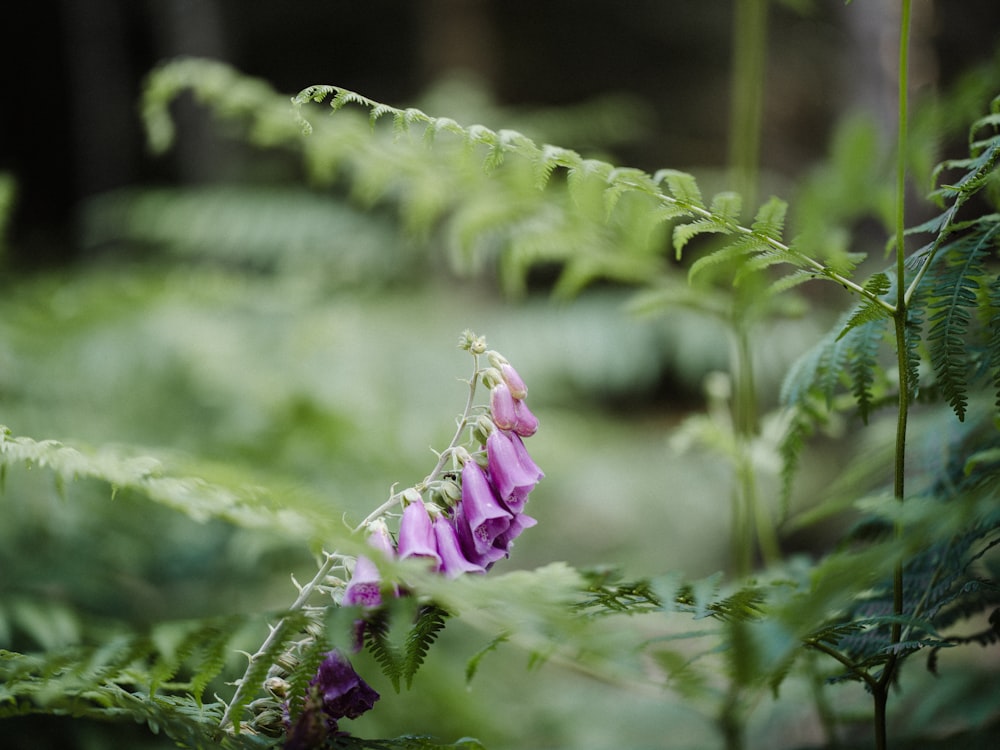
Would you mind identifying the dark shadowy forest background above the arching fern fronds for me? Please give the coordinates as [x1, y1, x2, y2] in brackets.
[7, 0, 1000, 274]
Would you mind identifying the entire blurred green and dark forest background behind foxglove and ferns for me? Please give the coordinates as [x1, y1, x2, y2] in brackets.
[0, 0, 1000, 749]
